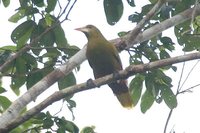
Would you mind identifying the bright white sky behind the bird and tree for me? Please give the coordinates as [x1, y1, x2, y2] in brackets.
[0, 0, 200, 133]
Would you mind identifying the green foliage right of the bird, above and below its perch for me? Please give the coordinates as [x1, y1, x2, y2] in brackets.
[126, 0, 200, 113]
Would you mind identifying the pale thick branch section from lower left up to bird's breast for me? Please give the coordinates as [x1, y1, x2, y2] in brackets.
[0, 48, 86, 127]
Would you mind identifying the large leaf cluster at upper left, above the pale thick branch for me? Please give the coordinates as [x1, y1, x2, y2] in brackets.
[0, 0, 79, 95]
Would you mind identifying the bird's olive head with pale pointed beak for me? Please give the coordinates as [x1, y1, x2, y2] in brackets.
[75, 25, 102, 40]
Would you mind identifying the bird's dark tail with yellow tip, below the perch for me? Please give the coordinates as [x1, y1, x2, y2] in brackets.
[109, 80, 133, 109]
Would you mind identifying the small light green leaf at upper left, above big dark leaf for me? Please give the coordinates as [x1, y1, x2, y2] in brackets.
[8, 9, 26, 23]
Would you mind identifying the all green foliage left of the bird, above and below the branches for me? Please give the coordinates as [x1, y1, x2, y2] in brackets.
[0, 0, 79, 133]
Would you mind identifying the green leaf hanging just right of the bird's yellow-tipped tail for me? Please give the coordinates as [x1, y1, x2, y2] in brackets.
[129, 74, 144, 106]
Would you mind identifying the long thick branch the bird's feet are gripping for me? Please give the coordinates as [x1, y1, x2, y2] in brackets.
[0, 52, 200, 132]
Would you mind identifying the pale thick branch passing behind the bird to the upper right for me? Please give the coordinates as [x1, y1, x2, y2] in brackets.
[0, 1, 200, 131]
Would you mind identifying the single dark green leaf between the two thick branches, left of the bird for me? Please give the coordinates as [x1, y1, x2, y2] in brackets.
[58, 72, 76, 90]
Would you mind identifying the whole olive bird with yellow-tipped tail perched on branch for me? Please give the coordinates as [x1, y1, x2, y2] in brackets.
[76, 25, 133, 108]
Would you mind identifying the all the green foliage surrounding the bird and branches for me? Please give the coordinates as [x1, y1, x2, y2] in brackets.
[0, 0, 200, 133]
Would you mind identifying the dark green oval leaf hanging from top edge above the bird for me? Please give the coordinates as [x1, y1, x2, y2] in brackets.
[103, 0, 124, 25]
